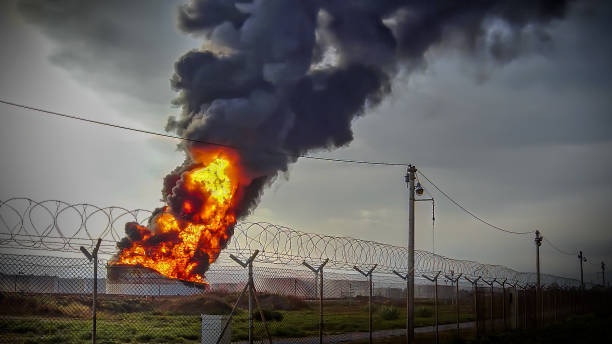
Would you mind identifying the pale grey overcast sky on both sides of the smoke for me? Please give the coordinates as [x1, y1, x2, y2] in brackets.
[0, 1, 612, 279]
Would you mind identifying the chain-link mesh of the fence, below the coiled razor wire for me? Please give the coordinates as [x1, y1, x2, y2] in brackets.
[0, 254, 598, 343]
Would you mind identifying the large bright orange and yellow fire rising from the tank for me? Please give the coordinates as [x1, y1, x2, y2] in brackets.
[115, 148, 249, 283]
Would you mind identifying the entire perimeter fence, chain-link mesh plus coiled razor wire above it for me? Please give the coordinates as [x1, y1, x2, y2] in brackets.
[0, 198, 596, 343]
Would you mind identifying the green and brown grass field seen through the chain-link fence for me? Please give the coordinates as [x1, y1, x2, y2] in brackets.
[0, 294, 473, 344]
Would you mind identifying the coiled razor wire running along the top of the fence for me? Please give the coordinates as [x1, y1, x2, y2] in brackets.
[0, 197, 578, 286]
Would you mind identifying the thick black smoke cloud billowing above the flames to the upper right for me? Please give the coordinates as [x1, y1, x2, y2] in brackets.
[165, 0, 568, 215]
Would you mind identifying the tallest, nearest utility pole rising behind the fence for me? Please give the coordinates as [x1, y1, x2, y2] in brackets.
[406, 165, 417, 343]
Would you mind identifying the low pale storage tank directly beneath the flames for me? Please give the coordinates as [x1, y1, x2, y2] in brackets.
[106, 263, 207, 296]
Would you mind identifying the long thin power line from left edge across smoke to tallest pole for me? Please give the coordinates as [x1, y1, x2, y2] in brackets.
[0, 99, 409, 167]
